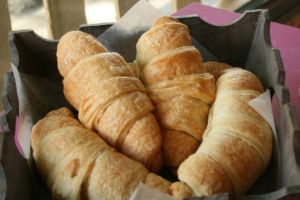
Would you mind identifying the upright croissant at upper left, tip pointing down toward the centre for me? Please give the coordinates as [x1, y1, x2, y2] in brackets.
[57, 31, 162, 171]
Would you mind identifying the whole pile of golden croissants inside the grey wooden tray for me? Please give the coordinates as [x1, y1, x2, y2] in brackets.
[31, 16, 272, 200]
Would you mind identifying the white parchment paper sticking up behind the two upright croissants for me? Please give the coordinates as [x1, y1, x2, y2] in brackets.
[97, 0, 217, 62]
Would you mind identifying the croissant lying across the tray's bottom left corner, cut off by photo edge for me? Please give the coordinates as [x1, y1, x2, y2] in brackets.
[31, 108, 193, 200]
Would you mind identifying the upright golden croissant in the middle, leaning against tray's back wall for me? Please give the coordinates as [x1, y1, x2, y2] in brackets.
[136, 17, 215, 171]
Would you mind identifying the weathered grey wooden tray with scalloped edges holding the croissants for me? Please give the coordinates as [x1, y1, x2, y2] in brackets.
[0, 10, 300, 200]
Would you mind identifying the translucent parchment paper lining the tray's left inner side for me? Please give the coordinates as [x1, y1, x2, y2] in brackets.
[12, 64, 67, 159]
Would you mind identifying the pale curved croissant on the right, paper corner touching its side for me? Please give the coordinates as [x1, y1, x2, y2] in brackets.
[178, 68, 272, 195]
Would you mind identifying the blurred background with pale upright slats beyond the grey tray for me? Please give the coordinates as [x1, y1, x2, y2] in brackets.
[0, 0, 300, 106]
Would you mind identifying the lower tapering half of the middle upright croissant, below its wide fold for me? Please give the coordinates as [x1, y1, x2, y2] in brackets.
[147, 74, 215, 168]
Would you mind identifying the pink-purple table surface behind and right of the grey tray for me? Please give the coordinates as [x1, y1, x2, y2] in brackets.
[175, 3, 300, 116]
